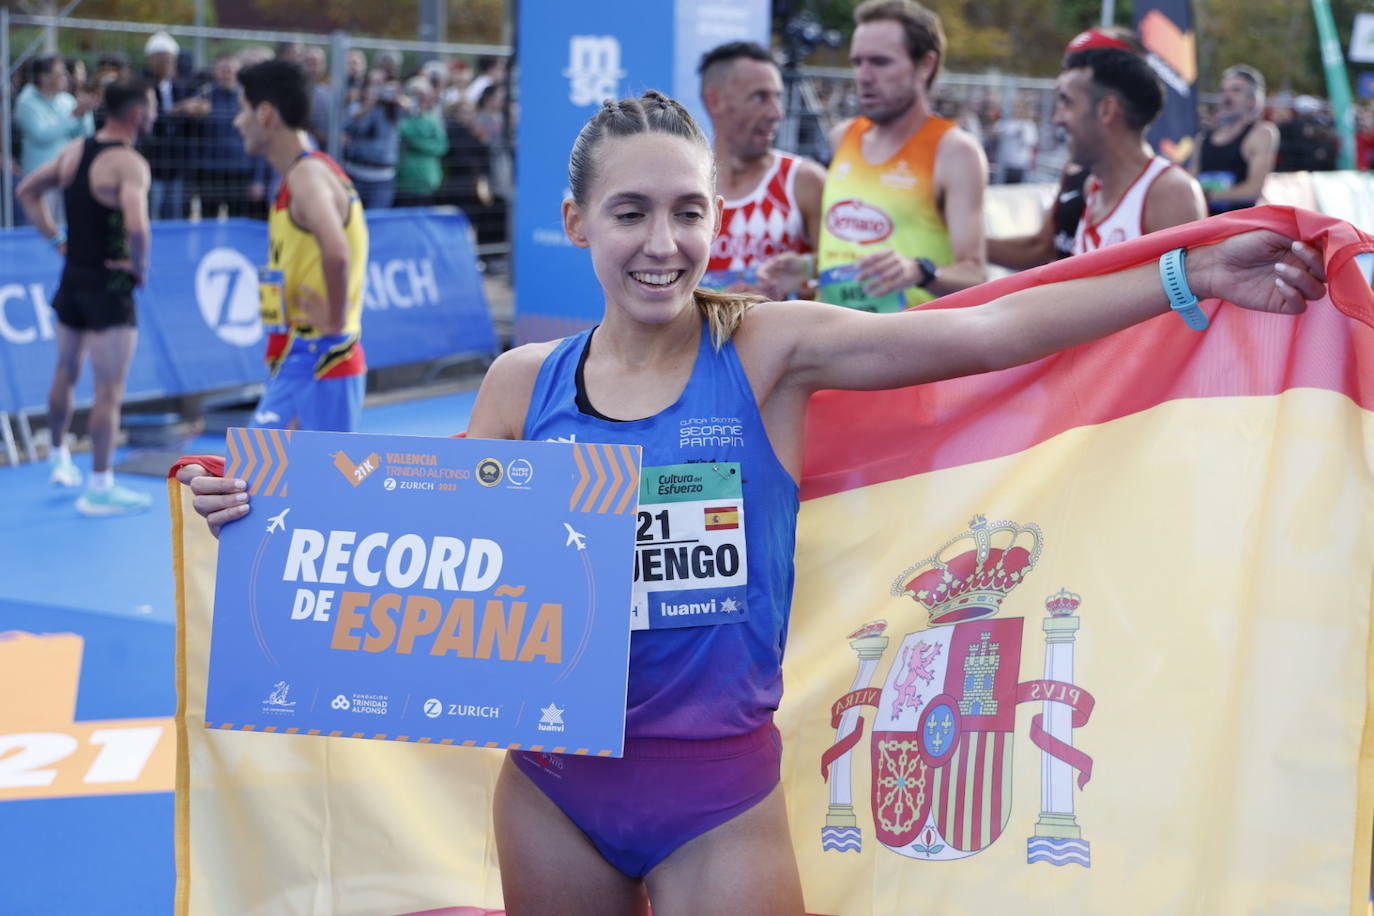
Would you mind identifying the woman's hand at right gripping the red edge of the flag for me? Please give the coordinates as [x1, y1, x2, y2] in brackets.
[1187, 229, 1326, 314]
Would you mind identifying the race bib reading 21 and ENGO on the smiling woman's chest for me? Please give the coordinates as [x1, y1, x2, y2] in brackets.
[629, 461, 749, 630]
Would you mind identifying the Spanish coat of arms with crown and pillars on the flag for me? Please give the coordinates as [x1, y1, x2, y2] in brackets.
[820, 516, 1094, 868]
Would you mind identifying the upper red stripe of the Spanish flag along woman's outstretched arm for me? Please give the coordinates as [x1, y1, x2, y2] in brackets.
[801, 207, 1374, 499]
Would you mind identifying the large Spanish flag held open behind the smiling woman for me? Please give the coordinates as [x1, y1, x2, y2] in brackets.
[172, 207, 1374, 916]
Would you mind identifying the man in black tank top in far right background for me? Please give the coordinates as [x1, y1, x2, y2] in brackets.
[1189, 65, 1279, 213]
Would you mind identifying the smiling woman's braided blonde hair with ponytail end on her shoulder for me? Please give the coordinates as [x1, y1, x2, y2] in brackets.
[567, 89, 764, 350]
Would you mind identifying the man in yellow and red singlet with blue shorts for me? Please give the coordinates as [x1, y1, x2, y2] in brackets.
[234, 59, 368, 433]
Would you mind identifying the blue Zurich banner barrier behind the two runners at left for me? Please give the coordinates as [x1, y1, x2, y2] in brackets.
[0, 209, 497, 463]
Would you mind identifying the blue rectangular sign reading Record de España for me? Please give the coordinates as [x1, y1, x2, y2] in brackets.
[205, 428, 640, 757]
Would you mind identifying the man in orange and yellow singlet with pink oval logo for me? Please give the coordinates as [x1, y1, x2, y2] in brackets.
[761, 0, 988, 312]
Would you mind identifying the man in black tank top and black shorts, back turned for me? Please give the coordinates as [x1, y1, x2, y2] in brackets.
[18, 80, 157, 515]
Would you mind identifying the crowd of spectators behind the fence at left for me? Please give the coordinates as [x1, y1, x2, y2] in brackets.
[7, 33, 513, 243]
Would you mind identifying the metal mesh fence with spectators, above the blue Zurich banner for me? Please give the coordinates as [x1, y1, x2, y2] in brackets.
[0, 10, 511, 257]
